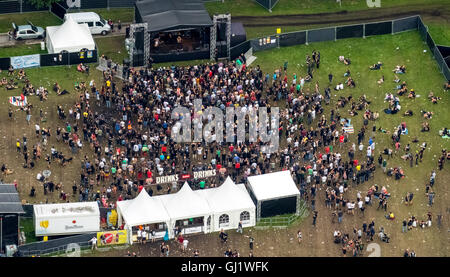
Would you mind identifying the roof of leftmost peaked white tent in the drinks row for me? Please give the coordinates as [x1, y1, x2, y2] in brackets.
[117, 189, 170, 226]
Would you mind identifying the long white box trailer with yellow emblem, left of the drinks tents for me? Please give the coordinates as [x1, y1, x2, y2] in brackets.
[33, 199, 100, 236]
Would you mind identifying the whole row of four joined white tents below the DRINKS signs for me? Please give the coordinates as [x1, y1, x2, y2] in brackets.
[117, 171, 300, 243]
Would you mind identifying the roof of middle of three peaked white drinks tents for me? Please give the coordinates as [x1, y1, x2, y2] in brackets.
[158, 182, 211, 220]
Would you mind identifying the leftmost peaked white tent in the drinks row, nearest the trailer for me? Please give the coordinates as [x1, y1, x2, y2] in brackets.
[117, 189, 170, 244]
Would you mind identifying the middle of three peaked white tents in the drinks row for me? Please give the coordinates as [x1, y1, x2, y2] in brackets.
[157, 182, 211, 238]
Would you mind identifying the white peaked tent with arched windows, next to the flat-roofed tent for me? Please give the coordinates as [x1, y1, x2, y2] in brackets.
[196, 177, 256, 232]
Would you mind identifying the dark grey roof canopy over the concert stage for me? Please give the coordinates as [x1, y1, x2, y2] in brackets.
[135, 0, 213, 32]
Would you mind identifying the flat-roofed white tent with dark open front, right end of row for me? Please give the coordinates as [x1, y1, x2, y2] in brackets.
[247, 170, 300, 219]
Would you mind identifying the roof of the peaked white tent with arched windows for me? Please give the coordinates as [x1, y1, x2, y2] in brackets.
[205, 176, 255, 213]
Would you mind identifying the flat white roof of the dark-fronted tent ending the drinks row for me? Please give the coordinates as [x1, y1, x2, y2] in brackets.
[248, 170, 300, 201]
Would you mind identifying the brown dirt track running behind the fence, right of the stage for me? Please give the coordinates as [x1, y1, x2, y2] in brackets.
[232, 4, 450, 27]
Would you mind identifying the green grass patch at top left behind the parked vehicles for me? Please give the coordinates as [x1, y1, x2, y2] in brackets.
[0, 11, 62, 33]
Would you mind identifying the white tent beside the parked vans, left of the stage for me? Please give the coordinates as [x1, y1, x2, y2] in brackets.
[45, 19, 95, 54]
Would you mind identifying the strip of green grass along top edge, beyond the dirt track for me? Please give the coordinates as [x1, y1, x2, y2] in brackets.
[205, 0, 445, 16]
